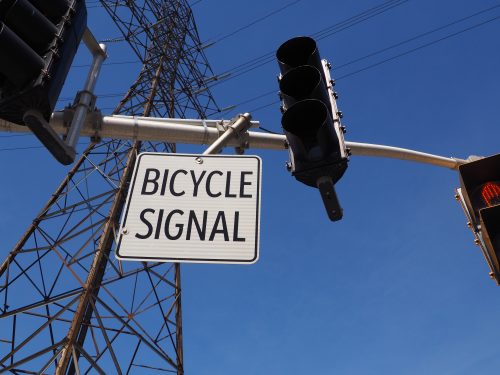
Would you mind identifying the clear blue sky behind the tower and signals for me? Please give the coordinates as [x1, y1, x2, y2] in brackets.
[0, 0, 500, 375]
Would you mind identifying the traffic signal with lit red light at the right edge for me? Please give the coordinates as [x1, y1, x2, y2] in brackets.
[458, 154, 500, 285]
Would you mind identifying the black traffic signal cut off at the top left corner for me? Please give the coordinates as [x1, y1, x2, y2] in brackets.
[0, 0, 87, 164]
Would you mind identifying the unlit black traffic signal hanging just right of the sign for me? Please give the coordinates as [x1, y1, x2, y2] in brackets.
[276, 37, 348, 220]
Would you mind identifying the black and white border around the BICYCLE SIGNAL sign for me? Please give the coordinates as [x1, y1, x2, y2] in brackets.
[115, 152, 262, 264]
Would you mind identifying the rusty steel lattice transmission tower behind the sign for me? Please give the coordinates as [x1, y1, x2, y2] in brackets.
[0, 0, 217, 374]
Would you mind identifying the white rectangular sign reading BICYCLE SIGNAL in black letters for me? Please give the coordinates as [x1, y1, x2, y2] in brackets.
[116, 153, 262, 263]
